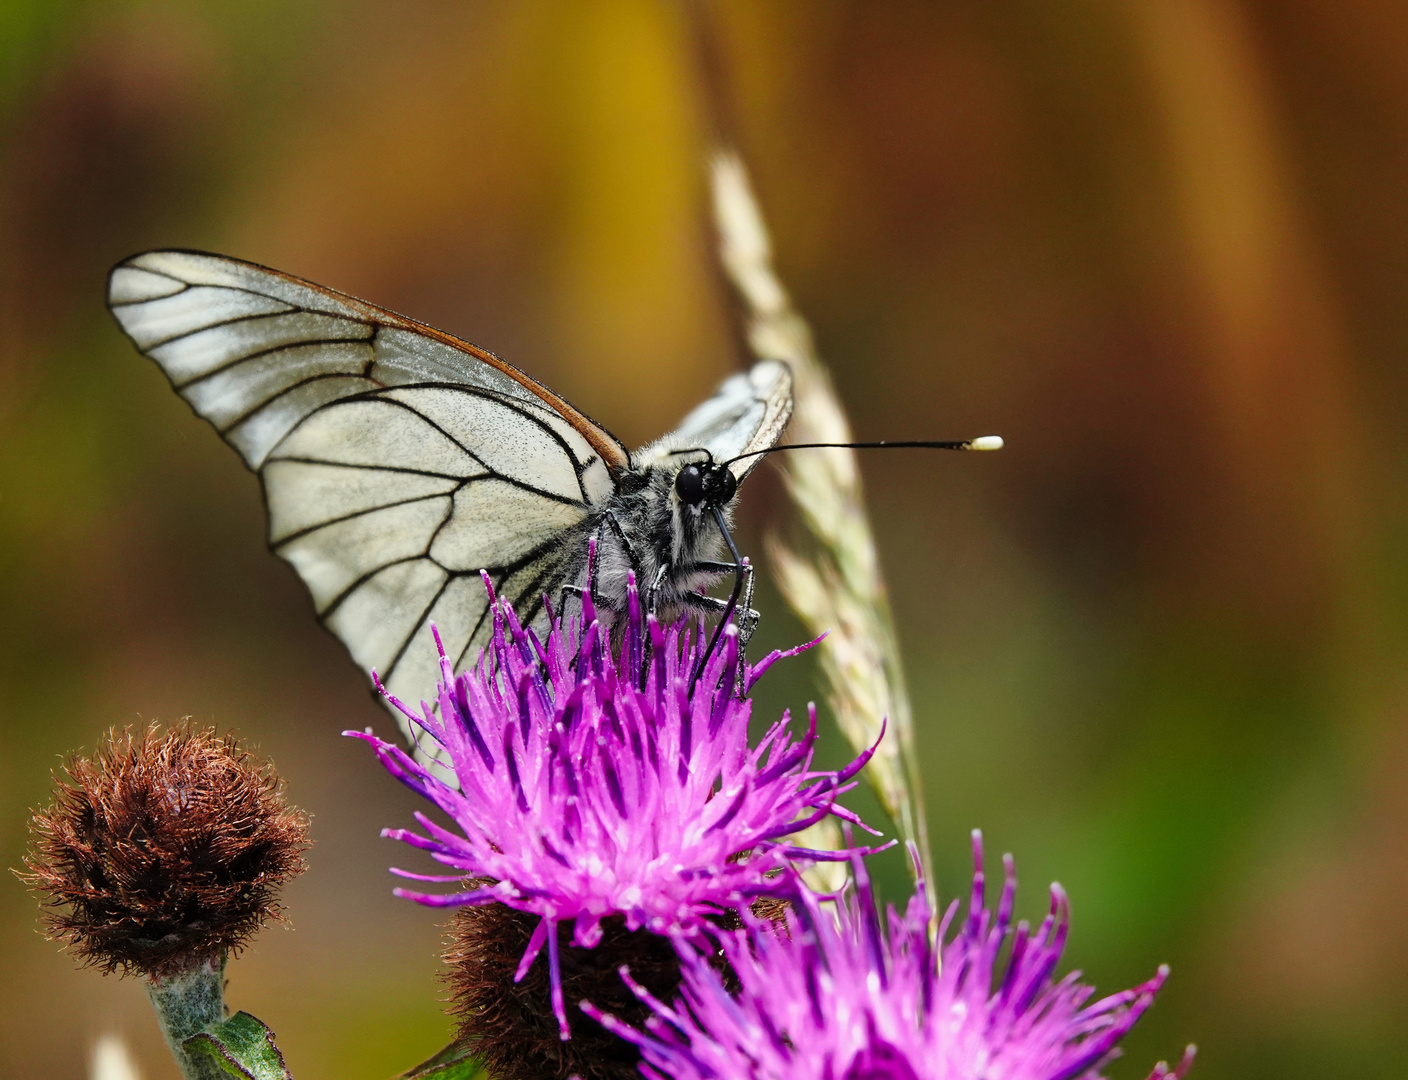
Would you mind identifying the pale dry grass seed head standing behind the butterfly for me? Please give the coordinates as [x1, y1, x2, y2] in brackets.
[711, 151, 934, 880]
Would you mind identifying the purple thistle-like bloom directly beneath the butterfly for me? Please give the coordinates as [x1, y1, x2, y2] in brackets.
[345, 576, 870, 1039]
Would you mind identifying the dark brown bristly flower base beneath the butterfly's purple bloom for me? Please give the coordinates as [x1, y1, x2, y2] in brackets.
[445, 897, 787, 1080]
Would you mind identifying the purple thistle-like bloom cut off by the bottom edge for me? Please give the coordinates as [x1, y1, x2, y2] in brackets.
[582, 832, 1193, 1080]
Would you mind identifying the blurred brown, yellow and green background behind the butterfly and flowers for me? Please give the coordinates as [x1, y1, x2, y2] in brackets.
[0, 0, 1408, 1080]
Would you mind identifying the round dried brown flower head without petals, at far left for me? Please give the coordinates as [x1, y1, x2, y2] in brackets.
[20, 724, 308, 977]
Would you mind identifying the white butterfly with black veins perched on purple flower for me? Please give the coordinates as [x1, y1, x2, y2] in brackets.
[107, 251, 793, 732]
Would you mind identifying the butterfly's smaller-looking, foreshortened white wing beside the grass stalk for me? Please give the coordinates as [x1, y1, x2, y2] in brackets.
[641, 360, 793, 480]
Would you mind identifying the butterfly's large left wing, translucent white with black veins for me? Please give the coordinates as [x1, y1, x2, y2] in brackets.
[108, 251, 628, 715]
